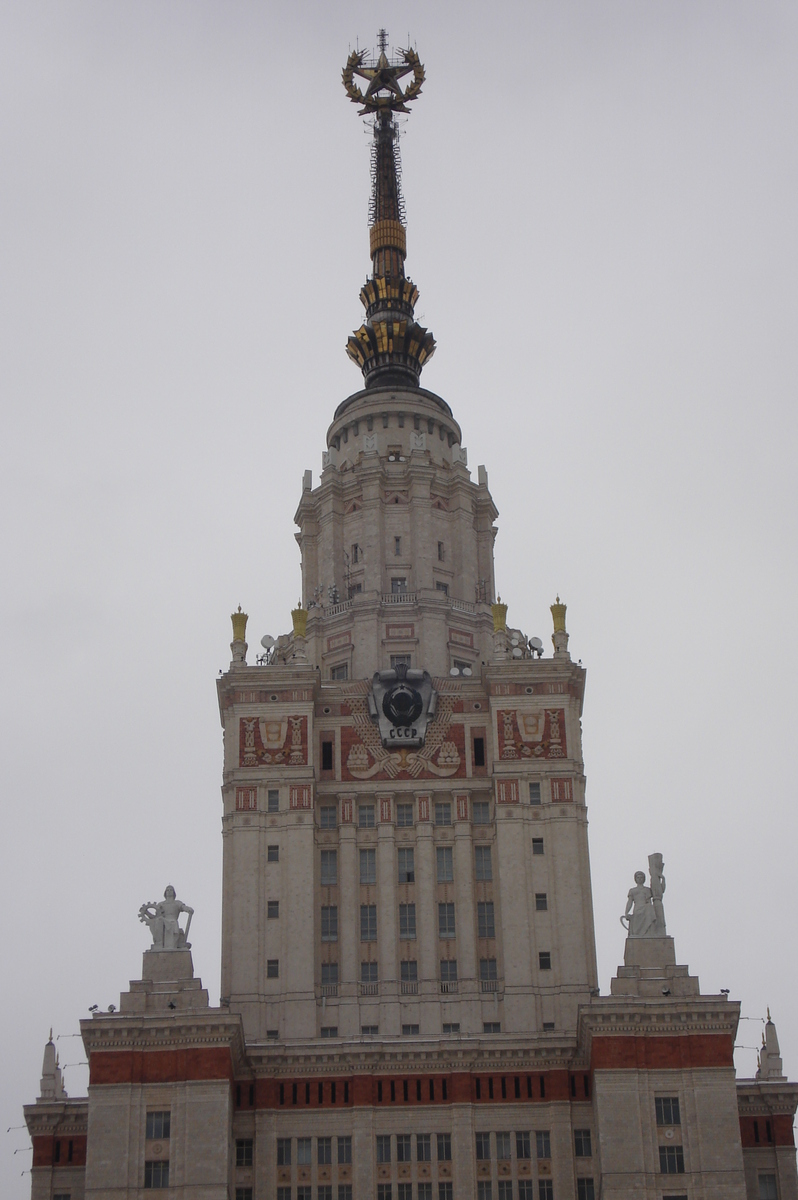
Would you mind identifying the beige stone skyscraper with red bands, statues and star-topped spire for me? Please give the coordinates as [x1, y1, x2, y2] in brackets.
[25, 35, 798, 1200]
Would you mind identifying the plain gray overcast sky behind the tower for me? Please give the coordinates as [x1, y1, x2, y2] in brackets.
[0, 0, 798, 1185]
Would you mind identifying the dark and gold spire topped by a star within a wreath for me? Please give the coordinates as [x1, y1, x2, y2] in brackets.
[343, 29, 436, 388]
